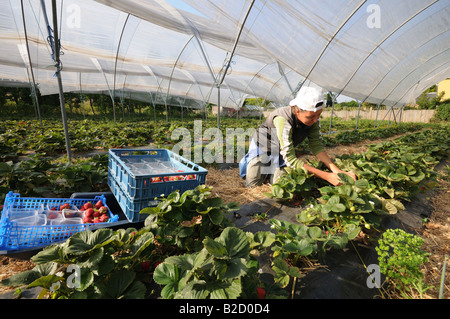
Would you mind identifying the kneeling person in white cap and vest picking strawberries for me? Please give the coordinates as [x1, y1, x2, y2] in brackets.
[239, 87, 356, 187]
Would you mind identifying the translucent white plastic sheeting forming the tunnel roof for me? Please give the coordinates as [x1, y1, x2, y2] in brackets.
[0, 0, 450, 108]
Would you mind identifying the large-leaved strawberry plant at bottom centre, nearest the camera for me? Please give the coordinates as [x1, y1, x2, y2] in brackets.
[153, 227, 282, 299]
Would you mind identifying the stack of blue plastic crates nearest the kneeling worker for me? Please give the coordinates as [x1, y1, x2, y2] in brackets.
[108, 149, 208, 222]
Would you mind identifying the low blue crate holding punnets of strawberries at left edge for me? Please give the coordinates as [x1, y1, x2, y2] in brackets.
[0, 192, 119, 251]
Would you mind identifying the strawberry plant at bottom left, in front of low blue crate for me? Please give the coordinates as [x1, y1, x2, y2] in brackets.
[2, 228, 160, 299]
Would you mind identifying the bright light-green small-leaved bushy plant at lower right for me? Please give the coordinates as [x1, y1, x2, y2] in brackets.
[375, 229, 429, 291]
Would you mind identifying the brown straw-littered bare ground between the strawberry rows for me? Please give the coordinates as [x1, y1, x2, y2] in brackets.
[0, 136, 450, 299]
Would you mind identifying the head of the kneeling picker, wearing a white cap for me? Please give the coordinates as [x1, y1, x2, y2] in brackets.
[289, 87, 326, 126]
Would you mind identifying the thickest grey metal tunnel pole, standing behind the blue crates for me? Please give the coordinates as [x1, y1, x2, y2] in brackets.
[50, 0, 72, 163]
